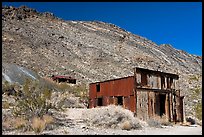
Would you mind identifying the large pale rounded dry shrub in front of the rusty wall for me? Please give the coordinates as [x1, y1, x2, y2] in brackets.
[84, 105, 142, 130]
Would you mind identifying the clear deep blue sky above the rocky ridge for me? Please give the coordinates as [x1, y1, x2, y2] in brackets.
[2, 2, 202, 56]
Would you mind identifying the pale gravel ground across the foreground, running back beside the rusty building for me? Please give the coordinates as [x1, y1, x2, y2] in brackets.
[3, 108, 202, 135]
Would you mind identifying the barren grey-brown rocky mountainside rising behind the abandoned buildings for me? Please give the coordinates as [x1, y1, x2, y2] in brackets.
[2, 6, 202, 119]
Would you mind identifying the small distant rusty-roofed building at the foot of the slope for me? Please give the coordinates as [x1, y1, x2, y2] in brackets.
[51, 75, 76, 84]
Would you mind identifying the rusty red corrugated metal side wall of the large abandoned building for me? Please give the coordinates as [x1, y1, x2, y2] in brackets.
[89, 76, 136, 112]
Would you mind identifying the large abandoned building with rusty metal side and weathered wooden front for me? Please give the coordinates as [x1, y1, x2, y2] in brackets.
[89, 68, 184, 122]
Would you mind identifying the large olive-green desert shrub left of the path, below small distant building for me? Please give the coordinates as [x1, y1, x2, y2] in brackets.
[13, 80, 51, 119]
